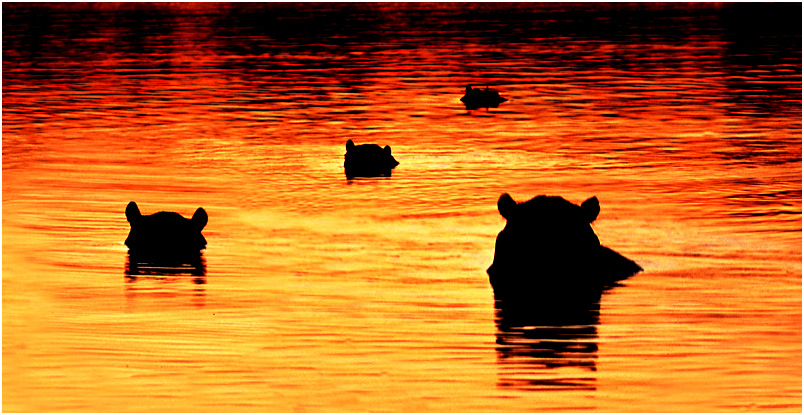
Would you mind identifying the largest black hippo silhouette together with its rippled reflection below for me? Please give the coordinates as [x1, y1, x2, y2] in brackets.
[488, 194, 642, 390]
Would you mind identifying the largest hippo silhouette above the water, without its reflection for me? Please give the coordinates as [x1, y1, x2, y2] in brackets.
[487, 193, 642, 302]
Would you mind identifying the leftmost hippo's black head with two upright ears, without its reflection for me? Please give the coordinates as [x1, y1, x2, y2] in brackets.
[126, 202, 209, 256]
